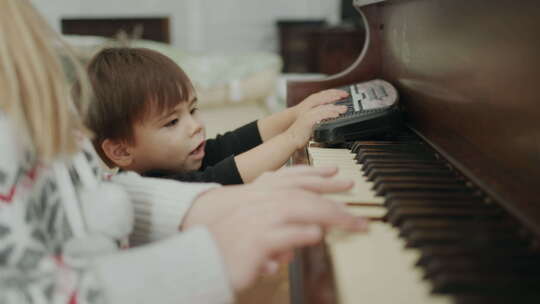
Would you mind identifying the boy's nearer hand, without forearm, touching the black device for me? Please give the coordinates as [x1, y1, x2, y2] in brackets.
[285, 104, 347, 149]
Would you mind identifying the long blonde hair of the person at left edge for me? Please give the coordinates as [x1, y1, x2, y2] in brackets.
[0, 0, 89, 161]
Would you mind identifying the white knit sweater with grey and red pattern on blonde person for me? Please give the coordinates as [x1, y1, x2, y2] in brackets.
[0, 113, 233, 304]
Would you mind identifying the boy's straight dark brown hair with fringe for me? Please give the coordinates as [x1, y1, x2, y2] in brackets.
[85, 48, 194, 166]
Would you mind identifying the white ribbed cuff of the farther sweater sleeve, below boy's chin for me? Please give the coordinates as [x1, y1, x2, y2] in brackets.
[108, 172, 219, 246]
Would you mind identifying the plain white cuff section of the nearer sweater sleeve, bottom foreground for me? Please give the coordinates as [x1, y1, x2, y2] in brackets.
[94, 227, 234, 304]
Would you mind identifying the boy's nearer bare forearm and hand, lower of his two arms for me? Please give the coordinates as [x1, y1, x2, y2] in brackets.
[234, 104, 347, 183]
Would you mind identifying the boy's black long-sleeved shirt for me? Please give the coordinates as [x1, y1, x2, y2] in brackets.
[143, 121, 262, 185]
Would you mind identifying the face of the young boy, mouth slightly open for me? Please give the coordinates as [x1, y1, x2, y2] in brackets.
[129, 96, 205, 172]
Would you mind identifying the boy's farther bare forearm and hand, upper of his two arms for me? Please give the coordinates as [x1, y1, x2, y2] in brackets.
[257, 89, 349, 142]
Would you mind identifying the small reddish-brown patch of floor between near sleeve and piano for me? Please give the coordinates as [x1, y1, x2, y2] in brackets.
[236, 265, 290, 304]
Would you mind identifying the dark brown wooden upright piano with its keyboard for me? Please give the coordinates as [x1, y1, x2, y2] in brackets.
[287, 0, 540, 304]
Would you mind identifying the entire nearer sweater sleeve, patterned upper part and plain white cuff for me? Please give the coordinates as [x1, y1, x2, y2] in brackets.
[0, 227, 234, 304]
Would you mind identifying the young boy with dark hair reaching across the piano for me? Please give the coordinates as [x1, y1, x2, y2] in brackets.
[86, 48, 347, 184]
